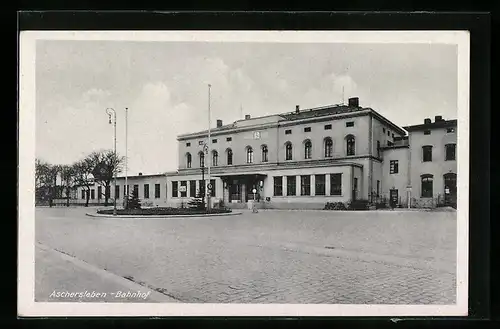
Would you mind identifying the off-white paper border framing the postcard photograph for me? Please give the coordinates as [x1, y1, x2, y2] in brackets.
[18, 31, 470, 317]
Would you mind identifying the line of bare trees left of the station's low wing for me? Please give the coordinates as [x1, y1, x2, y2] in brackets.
[35, 150, 125, 207]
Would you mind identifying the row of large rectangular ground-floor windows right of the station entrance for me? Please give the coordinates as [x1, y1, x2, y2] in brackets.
[273, 173, 342, 196]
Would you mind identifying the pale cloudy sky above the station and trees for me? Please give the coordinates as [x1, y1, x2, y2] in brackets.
[35, 40, 457, 175]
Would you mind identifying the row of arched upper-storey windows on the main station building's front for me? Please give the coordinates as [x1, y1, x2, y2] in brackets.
[186, 135, 356, 168]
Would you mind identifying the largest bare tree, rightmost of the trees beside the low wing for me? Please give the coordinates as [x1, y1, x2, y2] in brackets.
[88, 150, 125, 206]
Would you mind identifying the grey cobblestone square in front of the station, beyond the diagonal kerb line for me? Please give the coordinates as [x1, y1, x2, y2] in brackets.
[36, 208, 456, 304]
